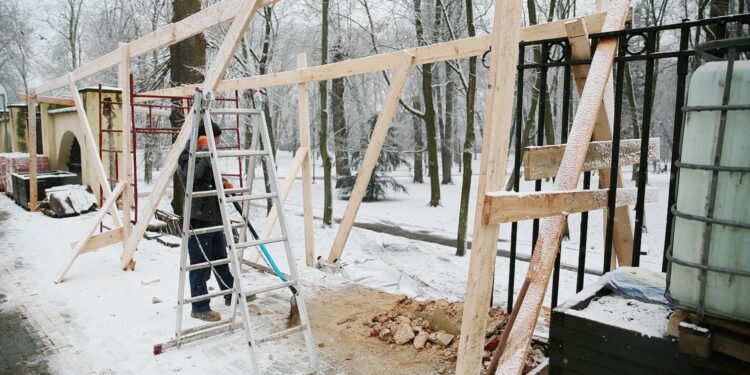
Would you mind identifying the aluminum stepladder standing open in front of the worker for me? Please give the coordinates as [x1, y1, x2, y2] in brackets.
[154, 91, 318, 374]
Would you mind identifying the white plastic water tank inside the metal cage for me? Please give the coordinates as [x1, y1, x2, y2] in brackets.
[667, 61, 750, 322]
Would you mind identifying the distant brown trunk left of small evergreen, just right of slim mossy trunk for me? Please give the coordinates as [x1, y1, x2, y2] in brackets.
[331, 46, 352, 188]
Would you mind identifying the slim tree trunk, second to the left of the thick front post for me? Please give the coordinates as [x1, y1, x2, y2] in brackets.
[414, 0, 440, 207]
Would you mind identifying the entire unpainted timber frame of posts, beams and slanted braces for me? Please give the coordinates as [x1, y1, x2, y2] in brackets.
[28, 0, 648, 374]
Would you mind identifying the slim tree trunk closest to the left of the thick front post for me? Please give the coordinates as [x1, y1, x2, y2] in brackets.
[456, 0, 477, 256]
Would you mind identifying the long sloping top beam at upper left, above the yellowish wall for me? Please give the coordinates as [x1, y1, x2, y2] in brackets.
[36, 0, 279, 94]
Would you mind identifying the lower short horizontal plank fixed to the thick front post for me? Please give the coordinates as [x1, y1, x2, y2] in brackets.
[482, 188, 658, 224]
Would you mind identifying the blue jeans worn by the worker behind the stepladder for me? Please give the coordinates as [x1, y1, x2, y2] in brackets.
[188, 219, 234, 312]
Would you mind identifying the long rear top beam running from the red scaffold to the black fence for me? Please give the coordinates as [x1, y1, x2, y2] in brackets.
[136, 12, 607, 101]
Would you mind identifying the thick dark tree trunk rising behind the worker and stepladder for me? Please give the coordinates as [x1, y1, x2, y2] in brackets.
[169, 0, 206, 216]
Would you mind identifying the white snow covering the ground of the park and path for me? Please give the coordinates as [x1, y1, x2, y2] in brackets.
[0, 148, 668, 374]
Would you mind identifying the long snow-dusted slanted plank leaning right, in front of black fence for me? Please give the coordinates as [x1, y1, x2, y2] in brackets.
[500, 0, 630, 374]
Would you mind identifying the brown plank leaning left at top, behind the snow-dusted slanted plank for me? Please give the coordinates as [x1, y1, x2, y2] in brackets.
[565, 16, 633, 268]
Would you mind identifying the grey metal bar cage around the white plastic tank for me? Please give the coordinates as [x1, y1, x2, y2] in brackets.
[665, 37, 750, 319]
